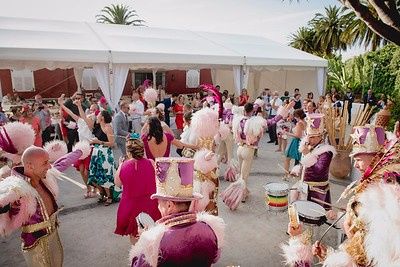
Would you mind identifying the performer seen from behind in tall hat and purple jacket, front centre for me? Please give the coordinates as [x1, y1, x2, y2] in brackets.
[130, 158, 225, 267]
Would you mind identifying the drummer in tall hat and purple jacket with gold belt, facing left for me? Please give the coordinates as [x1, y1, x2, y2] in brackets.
[292, 113, 336, 209]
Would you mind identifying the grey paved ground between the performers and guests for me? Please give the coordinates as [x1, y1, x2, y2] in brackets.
[0, 137, 352, 267]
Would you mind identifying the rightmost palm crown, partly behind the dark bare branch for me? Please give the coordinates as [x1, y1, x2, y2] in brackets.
[342, 10, 388, 51]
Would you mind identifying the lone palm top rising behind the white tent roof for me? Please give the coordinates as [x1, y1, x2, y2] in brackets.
[96, 4, 145, 26]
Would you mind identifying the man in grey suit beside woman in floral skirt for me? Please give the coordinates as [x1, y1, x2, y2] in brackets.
[114, 101, 129, 156]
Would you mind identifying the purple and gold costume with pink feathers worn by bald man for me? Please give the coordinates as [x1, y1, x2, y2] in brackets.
[0, 144, 87, 266]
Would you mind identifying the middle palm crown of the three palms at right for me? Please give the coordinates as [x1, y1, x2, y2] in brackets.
[310, 6, 347, 56]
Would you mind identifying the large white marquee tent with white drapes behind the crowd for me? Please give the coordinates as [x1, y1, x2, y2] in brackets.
[0, 17, 327, 110]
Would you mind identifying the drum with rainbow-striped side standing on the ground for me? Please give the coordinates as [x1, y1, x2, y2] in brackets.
[264, 183, 289, 211]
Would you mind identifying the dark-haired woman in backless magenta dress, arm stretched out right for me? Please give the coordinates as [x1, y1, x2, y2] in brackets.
[142, 117, 197, 160]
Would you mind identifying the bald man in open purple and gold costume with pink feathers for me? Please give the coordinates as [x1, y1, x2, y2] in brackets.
[0, 136, 90, 267]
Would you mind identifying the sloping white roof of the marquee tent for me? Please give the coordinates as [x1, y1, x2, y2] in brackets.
[0, 17, 327, 69]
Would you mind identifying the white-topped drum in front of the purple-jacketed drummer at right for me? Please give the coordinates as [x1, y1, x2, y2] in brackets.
[293, 200, 326, 226]
